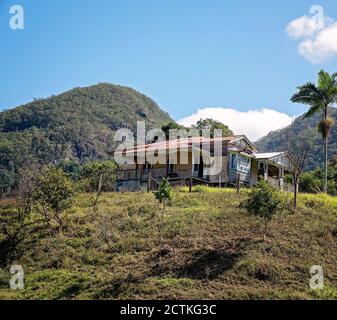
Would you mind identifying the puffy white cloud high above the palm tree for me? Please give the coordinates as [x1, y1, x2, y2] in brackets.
[286, 16, 337, 64]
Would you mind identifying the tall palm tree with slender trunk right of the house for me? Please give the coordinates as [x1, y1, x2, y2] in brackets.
[291, 70, 337, 193]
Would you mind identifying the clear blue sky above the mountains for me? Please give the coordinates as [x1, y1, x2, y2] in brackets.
[0, 0, 337, 139]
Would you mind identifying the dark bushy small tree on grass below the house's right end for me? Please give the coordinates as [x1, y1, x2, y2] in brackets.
[243, 181, 283, 240]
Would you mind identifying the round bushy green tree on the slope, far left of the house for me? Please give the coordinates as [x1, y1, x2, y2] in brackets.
[33, 167, 75, 230]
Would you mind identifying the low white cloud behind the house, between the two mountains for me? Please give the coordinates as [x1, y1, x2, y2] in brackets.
[178, 108, 292, 141]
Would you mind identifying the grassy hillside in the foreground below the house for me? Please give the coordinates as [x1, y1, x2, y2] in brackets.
[0, 187, 337, 299]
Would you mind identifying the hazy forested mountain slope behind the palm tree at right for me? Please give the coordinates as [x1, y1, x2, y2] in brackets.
[255, 108, 337, 170]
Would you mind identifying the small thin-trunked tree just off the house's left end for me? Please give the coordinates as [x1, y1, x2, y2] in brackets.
[81, 160, 117, 212]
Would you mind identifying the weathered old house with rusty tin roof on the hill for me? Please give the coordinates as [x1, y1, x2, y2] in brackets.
[115, 135, 295, 191]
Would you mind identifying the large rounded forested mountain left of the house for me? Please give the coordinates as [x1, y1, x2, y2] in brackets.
[0, 83, 172, 188]
